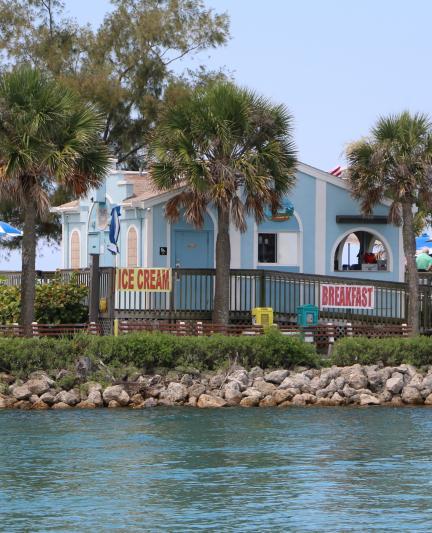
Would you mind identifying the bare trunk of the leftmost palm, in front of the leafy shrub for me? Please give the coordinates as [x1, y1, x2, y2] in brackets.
[20, 193, 36, 335]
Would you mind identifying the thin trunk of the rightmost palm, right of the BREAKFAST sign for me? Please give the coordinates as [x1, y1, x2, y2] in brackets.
[402, 202, 419, 335]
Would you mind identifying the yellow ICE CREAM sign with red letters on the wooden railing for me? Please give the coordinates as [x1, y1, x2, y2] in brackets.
[116, 268, 172, 292]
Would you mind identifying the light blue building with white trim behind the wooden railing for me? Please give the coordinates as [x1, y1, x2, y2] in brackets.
[55, 158, 404, 281]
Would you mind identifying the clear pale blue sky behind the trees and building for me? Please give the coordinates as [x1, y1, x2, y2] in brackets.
[0, 0, 432, 270]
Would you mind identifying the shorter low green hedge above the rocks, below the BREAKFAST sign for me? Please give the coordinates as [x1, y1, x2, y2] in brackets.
[332, 337, 432, 367]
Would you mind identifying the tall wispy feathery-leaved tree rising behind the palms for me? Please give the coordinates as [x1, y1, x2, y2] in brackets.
[0, 0, 229, 168]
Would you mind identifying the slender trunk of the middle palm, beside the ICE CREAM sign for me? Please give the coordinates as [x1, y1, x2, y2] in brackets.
[213, 207, 231, 324]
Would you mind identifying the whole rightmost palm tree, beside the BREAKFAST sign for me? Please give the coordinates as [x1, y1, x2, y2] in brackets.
[347, 111, 432, 334]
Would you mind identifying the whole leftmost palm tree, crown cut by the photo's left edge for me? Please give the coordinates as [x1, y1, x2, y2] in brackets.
[0, 66, 109, 329]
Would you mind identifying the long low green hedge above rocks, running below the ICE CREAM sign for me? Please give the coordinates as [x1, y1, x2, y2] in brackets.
[0, 332, 320, 374]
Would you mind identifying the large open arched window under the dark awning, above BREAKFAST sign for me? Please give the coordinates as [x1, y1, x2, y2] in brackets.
[333, 230, 390, 272]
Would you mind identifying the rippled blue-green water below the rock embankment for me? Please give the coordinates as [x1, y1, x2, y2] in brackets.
[0, 408, 432, 533]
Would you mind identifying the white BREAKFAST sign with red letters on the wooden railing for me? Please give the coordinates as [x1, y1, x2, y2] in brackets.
[320, 284, 375, 309]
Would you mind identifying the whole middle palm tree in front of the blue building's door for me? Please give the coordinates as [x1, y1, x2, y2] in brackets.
[151, 82, 296, 324]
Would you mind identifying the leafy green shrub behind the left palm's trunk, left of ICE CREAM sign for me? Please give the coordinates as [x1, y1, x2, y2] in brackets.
[0, 279, 88, 324]
